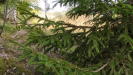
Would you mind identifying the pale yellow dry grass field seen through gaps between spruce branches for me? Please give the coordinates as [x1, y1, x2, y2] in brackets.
[29, 12, 93, 32]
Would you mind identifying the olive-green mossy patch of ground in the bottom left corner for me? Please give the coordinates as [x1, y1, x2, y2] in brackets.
[0, 58, 32, 75]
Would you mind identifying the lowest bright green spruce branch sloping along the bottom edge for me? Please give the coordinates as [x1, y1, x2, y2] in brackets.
[12, 41, 102, 75]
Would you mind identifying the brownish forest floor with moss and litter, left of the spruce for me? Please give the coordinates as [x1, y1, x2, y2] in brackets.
[0, 25, 34, 75]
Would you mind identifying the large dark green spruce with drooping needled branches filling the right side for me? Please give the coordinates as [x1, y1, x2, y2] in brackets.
[9, 0, 133, 75]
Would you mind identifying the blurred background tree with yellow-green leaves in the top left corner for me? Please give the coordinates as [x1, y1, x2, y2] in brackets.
[0, 0, 39, 34]
